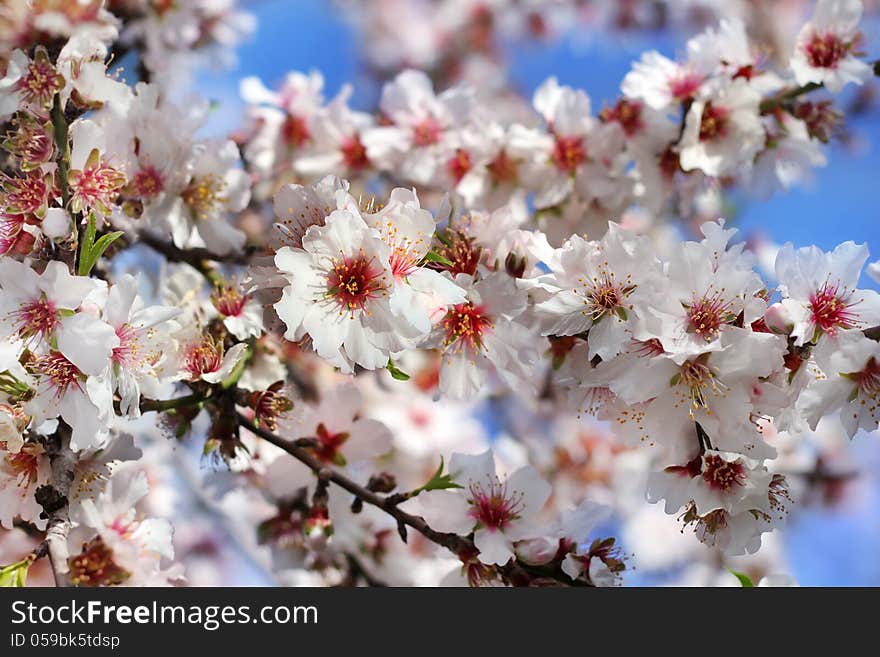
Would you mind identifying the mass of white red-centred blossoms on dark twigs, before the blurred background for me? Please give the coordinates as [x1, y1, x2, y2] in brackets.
[0, 0, 880, 586]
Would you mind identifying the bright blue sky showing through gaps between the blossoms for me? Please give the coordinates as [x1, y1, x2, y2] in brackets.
[197, 0, 880, 585]
